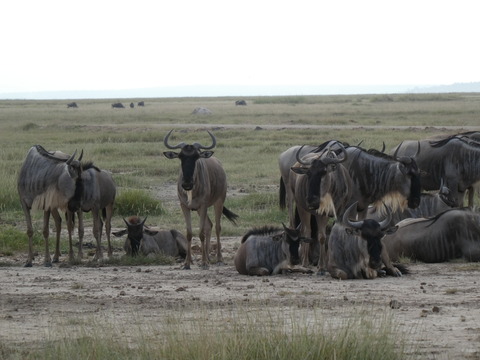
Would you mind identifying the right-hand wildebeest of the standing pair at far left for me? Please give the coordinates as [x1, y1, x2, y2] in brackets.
[67, 163, 116, 260]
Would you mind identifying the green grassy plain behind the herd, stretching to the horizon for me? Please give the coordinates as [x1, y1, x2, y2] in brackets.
[0, 93, 480, 239]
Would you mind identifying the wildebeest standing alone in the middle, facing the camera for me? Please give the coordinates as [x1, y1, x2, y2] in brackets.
[163, 130, 238, 269]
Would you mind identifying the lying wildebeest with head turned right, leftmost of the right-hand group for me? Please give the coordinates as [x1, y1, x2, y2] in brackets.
[234, 225, 311, 276]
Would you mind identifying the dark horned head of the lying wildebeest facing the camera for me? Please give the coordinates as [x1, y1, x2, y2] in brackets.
[343, 202, 398, 270]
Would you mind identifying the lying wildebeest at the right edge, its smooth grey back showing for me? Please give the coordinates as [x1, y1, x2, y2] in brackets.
[383, 208, 480, 263]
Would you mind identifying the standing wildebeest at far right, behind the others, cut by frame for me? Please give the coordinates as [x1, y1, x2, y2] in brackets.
[394, 135, 480, 207]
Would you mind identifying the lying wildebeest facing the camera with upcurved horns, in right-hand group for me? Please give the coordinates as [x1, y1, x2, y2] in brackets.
[328, 203, 402, 280]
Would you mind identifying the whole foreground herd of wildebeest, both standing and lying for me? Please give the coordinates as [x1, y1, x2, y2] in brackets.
[18, 130, 480, 279]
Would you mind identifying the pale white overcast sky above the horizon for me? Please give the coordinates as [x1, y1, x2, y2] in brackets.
[0, 0, 480, 95]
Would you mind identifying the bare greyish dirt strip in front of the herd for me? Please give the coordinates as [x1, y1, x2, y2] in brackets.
[0, 233, 480, 359]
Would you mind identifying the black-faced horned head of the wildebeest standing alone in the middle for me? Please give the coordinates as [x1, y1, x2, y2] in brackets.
[163, 130, 217, 191]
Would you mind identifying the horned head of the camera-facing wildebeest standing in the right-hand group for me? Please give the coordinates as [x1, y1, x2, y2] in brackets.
[291, 143, 347, 210]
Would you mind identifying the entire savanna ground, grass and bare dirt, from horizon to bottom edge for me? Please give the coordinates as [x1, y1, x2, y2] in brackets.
[0, 93, 480, 359]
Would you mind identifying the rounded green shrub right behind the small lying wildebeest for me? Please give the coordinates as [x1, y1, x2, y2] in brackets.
[115, 190, 164, 216]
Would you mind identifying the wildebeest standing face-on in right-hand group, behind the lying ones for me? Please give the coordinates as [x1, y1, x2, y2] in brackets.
[289, 143, 352, 274]
